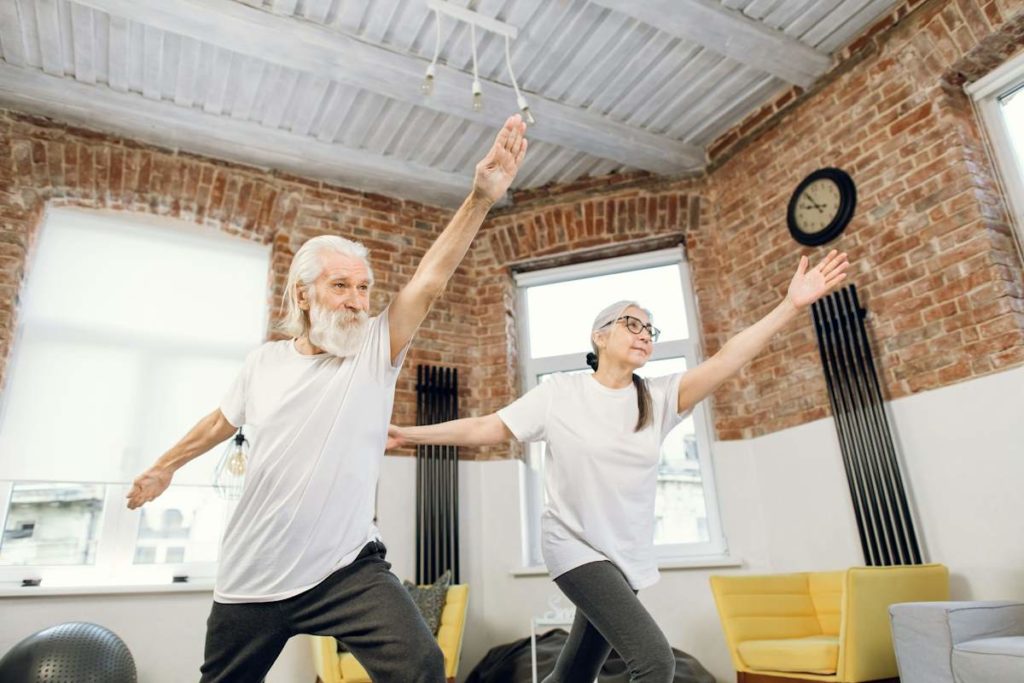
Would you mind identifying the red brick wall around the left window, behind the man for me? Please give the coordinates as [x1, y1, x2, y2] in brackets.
[0, 111, 475, 436]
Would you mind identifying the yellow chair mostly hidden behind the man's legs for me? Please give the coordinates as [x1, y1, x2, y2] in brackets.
[312, 584, 469, 683]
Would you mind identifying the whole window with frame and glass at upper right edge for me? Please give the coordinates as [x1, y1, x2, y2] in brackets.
[967, 54, 1024, 249]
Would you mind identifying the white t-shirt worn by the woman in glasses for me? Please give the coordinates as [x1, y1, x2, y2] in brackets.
[498, 373, 686, 590]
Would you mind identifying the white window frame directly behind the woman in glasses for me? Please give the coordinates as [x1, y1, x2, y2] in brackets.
[513, 245, 728, 566]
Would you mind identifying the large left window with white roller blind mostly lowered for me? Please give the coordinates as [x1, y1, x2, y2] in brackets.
[0, 210, 269, 587]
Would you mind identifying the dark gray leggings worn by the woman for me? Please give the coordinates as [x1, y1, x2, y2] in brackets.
[544, 561, 676, 683]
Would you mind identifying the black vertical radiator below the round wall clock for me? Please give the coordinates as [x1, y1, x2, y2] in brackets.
[811, 285, 922, 566]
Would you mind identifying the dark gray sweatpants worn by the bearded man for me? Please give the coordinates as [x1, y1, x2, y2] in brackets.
[200, 541, 444, 683]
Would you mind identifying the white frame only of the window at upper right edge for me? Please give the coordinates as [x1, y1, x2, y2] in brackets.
[964, 54, 1024, 253]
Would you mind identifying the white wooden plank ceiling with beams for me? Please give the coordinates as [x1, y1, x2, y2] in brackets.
[0, 0, 897, 206]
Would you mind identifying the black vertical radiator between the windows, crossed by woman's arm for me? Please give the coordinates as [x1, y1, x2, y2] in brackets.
[416, 366, 459, 585]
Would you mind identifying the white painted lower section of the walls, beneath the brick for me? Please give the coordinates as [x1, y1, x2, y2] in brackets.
[0, 369, 1024, 683]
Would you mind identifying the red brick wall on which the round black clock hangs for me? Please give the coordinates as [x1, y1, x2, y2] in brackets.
[701, 1, 1024, 438]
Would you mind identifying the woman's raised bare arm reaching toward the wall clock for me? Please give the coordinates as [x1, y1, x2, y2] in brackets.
[679, 249, 849, 413]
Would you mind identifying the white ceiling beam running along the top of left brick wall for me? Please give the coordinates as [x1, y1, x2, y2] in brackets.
[0, 62, 475, 207]
